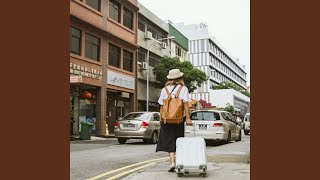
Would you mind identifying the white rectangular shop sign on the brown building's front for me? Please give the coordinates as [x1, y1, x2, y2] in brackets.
[107, 71, 135, 89]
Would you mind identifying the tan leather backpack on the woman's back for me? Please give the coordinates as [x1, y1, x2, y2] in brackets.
[160, 86, 184, 124]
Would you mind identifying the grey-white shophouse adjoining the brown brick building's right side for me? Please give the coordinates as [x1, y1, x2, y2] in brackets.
[137, 4, 173, 111]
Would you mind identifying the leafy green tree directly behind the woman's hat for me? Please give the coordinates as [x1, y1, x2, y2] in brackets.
[152, 57, 208, 93]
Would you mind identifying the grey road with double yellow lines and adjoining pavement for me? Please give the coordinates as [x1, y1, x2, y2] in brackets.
[70, 131, 250, 180]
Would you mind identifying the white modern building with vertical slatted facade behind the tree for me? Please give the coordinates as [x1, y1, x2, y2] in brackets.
[172, 23, 249, 114]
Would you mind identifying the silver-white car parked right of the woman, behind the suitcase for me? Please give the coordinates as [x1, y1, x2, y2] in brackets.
[186, 110, 241, 143]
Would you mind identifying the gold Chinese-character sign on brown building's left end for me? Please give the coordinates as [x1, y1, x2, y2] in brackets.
[70, 63, 102, 82]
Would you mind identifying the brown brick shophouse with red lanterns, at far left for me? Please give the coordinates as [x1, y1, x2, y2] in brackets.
[70, 0, 139, 135]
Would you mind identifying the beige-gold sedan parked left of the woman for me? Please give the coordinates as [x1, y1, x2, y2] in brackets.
[114, 112, 160, 144]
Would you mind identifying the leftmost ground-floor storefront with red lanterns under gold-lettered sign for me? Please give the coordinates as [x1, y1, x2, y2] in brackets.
[70, 60, 102, 135]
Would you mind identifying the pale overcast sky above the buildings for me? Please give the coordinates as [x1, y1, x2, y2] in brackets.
[138, 0, 250, 86]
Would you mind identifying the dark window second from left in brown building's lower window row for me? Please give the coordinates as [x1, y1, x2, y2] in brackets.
[85, 33, 100, 61]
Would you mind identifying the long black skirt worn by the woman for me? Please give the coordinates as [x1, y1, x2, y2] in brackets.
[156, 120, 185, 152]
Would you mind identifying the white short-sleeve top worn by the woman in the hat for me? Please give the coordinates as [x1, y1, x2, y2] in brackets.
[158, 85, 191, 105]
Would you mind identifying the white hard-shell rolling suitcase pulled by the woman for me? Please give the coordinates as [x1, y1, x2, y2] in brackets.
[176, 124, 207, 177]
